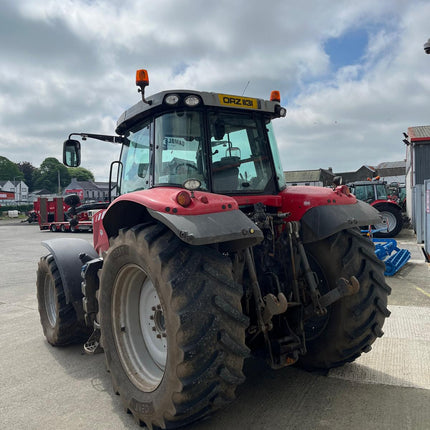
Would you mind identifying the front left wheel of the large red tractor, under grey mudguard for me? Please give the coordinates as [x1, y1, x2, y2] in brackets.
[36, 254, 90, 346]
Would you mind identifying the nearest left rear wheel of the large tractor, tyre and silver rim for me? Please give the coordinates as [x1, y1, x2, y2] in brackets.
[98, 224, 249, 429]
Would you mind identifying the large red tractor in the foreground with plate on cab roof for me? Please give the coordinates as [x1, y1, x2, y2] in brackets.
[37, 70, 390, 429]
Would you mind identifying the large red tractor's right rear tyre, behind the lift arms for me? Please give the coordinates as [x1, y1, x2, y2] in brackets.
[299, 230, 391, 369]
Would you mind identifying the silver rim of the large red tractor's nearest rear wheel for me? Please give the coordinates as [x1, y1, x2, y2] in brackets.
[111, 264, 167, 392]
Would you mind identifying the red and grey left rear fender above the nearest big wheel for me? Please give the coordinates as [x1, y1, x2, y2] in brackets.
[103, 187, 263, 249]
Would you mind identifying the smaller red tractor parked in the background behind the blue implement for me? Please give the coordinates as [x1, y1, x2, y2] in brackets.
[348, 180, 403, 237]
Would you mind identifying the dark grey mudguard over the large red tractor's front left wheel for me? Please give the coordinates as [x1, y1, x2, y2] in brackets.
[42, 239, 98, 303]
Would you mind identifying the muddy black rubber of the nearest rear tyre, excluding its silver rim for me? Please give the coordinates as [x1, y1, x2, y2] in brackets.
[99, 223, 245, 429]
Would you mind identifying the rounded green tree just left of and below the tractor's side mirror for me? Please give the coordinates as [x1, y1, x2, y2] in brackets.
[33, 157, 70, 193]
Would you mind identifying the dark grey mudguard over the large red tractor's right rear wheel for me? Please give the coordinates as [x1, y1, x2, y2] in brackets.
[300, 200, 381, 243]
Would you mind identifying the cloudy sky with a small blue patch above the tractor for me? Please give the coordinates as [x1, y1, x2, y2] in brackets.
[0, 0, 430, 180]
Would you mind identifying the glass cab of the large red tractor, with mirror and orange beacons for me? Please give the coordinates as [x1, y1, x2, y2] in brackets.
[64, 71, 286, 200]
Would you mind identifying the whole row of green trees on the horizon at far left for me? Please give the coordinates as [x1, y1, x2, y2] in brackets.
[0, 156, 94, 193]
